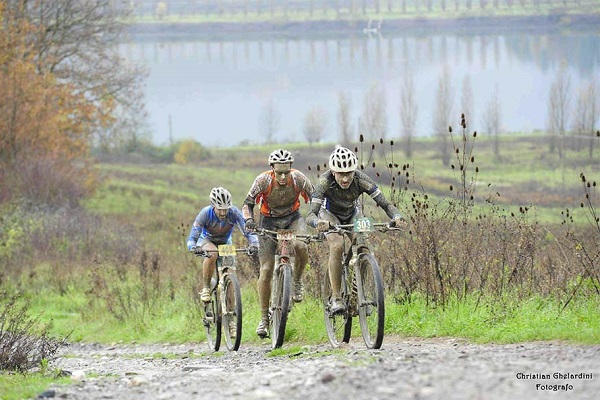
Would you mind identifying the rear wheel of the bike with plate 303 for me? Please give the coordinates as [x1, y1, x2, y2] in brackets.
[323, 270, 352, 348]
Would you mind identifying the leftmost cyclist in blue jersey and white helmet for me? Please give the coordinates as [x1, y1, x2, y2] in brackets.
[187, 187, 258, 303]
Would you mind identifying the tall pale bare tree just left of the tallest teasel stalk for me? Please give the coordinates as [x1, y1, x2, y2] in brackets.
[433, 66, 453, 165]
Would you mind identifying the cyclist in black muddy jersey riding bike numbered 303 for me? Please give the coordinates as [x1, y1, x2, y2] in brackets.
[306, 147, 404, 313]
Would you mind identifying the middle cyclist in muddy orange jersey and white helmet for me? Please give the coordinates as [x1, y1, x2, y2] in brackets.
[242, 149, 313, 338]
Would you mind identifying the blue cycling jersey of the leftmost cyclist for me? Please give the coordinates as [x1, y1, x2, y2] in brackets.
[187, 206, 258, 250]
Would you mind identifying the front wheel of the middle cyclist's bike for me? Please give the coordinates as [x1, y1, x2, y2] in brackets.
[270, 264, 292, 349]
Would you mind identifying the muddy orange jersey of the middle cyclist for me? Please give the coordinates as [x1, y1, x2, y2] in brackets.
[244, 169, 313, 218]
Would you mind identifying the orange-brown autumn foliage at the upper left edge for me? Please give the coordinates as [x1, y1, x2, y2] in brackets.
[0, 2, 111, 206]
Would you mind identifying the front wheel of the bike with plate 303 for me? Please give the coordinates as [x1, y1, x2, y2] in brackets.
[354, 253, 385, 349]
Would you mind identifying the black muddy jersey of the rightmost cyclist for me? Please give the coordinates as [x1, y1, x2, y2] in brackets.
[306, 170, 400, 227]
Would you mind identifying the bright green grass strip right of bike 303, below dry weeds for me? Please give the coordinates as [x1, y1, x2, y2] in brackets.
[386, 295, 600, 344]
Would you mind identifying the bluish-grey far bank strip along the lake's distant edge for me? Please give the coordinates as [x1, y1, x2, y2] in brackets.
[129, 14, 600, 37]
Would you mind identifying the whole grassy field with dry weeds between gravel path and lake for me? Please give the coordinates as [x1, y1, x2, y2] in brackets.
[0, 135, 600, 398]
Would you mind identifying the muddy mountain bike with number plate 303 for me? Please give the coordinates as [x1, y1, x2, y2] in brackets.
[323, 218, 401, 349]
